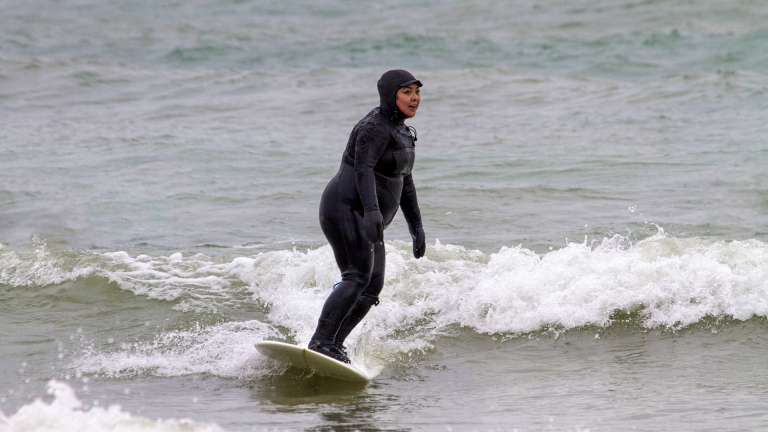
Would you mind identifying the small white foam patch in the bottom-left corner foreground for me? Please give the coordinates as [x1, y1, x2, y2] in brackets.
[0, 380, 224, 432]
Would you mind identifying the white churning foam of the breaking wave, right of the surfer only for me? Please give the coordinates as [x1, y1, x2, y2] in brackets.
[374, 232, 768, 333]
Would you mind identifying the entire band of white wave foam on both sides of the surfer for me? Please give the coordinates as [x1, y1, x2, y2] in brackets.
[0, 231, 768, 377]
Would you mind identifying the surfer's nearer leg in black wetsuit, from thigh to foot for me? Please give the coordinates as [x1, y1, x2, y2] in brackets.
[309, 207, 374, 363]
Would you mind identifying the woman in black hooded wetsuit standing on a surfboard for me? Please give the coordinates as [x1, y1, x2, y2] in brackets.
[308, 69, 426, 363]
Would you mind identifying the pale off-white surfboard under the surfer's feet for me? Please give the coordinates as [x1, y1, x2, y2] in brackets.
[255, 341, 371, 382]
